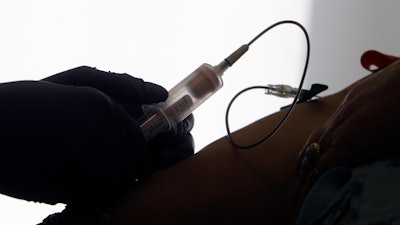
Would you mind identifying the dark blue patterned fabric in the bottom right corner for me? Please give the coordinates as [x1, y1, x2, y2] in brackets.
[296, 157, 400, 225]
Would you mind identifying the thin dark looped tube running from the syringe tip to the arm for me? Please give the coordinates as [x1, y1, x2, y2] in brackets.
[225, 20, 310, 149]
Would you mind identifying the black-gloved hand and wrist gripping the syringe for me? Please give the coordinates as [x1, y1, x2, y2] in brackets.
[0, 67, 193, 204]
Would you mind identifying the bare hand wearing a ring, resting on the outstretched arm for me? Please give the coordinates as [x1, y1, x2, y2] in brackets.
[296, 61, 400, 214]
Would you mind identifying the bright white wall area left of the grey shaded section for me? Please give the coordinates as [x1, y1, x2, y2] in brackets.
[0, 0, 308, 225]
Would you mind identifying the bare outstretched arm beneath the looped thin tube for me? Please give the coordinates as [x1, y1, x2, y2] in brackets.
[110, 60, 400, 225]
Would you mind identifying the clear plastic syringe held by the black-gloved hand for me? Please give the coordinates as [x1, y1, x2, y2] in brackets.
[139, 44, 249, 141]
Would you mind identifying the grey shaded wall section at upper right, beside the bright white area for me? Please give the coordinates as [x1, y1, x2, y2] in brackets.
[308, 0, 400, 96]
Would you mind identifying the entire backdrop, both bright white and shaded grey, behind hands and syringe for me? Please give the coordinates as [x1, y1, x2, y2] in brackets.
[0, 0, 400, 225]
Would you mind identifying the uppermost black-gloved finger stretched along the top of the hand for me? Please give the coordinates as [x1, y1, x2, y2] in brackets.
[43, 66, 168, 104]
